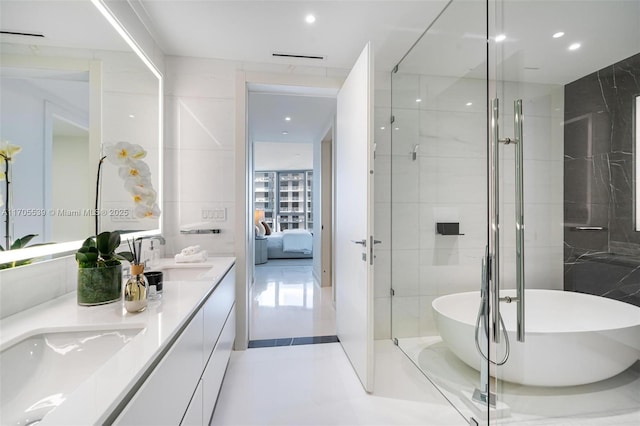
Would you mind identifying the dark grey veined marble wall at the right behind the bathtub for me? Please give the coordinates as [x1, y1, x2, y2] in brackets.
[564, 54, 640, 306]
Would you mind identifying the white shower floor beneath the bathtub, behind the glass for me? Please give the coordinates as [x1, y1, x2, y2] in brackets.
[398, 336, 640, 426]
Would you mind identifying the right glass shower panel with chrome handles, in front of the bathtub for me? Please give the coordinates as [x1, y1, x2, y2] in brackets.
[488, 0, 640, 425]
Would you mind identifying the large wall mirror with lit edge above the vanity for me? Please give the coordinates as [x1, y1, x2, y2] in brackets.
[0, 0, 162, 264]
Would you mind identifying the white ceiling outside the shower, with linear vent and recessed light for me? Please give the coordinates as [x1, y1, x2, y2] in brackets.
[139, 0, 447, 71]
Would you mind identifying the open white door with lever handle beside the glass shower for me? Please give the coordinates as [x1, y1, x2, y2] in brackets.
[334, 43, 374, 392]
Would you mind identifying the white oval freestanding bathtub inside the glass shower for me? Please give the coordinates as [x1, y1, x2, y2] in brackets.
[432, 290, 640, 386]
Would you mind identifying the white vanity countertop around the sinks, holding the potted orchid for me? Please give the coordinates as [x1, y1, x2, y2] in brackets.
[0, 257, 235, 425]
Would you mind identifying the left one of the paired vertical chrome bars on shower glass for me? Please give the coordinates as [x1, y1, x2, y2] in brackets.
[489, 98, 500, 342]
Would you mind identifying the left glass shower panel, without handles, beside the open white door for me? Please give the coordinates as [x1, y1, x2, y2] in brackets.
[391, 1, 488, 419]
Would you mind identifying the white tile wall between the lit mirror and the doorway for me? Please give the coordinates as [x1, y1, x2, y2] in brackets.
[164, 57, 239, 256]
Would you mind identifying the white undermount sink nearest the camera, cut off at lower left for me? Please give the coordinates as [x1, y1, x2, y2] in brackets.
[0, 328, 142, 425]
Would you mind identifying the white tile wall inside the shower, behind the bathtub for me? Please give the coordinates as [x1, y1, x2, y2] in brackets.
[391, 75, 564, 337]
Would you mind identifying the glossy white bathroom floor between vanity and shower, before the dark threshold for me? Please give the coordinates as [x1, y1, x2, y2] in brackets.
[211, 340, 468, 426]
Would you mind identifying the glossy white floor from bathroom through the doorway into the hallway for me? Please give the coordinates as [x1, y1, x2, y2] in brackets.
[211, 262, 468, 426]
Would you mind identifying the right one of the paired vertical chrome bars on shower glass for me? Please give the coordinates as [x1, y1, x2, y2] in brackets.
[513, 99, 525, 342]
